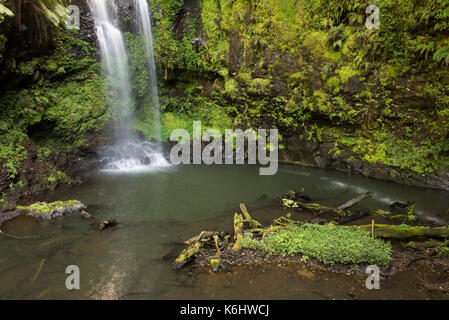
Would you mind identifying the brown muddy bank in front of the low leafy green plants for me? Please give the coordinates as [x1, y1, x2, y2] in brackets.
[174, 263, 449, 300]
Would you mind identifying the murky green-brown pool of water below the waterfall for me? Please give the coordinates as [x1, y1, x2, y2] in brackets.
[0, 166, 449, 299]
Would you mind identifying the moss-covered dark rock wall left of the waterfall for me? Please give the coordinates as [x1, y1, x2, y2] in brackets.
[0, 29, 111, 207]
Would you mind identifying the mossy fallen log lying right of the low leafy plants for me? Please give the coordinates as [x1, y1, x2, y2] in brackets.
[352, 224, 449, 240]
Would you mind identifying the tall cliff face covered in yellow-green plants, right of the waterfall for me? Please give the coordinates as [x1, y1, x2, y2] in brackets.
[144, 0, 449, 190]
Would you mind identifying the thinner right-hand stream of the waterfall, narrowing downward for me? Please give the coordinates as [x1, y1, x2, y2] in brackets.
[134, 0, 161, 140]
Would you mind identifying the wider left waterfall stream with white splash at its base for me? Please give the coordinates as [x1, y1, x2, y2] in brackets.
[89, 0, 169, 172]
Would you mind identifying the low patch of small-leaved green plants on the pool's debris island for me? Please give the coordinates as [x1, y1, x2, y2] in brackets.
[242, 224, 391, 265]
